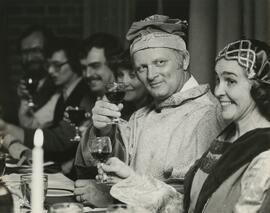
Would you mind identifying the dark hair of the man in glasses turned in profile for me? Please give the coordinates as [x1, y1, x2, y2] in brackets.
[46, 37, 82, 75]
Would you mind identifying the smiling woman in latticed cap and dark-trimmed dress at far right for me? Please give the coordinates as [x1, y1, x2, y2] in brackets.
[185, 40, 270, 213]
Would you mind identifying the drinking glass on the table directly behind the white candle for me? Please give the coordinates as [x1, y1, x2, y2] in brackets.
[20, 173, 48, 208]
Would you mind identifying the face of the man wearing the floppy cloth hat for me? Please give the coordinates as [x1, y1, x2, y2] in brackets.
[133, 48, 188, 102]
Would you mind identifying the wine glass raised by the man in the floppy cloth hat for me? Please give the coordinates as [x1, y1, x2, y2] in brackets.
[105, 82, 126, 124]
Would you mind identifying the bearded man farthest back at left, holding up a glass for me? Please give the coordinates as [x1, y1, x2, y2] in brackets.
[17, 26, 56, 128]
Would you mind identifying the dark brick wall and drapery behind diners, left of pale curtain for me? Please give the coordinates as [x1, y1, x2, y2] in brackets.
[0, 0, 189, 123]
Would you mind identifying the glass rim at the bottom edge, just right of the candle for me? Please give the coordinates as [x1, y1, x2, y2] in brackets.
[49, 202, 83, 213]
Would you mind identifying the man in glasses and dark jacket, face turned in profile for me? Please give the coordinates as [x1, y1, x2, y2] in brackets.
[0, 37, 95, 178]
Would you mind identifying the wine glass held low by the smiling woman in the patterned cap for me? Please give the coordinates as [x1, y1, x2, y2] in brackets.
[88, 136, 112, 183]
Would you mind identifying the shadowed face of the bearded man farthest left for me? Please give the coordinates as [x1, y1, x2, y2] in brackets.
[21, 32, 46, 75]
